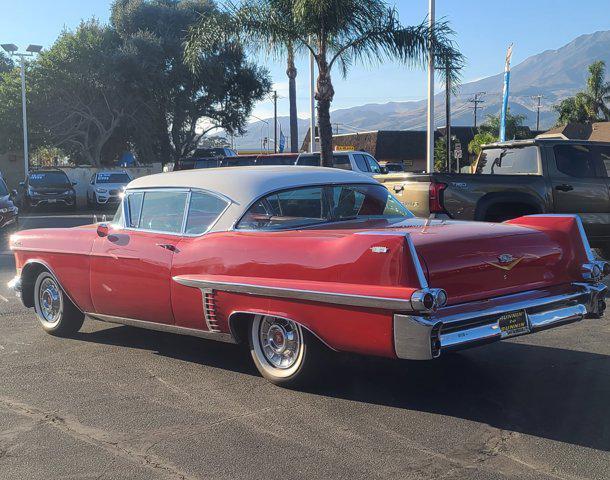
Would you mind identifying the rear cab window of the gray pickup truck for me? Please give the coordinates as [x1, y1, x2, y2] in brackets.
[476, 145, 539, 175]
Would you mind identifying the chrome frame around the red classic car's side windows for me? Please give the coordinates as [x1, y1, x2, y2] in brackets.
[113, 187, 235, 238]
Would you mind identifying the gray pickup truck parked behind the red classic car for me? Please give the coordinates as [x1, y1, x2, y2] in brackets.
[378, 138, 610, 255]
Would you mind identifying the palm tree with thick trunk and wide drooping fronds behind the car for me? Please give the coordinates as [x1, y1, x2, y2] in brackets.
[186, 0, 463, 166]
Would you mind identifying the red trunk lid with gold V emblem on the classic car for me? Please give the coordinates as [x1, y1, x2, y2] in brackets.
[409, 221, 576, 304]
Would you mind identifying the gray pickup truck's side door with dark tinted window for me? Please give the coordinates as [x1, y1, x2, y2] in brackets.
[549, 144, 610, 239]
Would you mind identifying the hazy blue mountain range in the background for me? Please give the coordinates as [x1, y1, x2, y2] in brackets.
[235, 30, 610, 149]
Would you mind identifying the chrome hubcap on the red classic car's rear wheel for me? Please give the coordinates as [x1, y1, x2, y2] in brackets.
[259, 317, 301, 368]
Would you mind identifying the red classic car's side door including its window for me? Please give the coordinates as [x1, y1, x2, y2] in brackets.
[91, 189, 190, 324]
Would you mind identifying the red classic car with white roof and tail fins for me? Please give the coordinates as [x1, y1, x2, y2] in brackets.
[5, 166, 610, 384]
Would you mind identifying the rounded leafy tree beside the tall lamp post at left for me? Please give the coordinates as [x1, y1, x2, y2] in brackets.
[30, 20, 147, 166]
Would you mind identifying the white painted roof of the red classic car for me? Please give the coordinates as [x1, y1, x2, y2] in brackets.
[127, 165, 378, 206]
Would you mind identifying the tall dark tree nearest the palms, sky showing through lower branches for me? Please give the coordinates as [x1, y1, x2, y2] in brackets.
[111, 0, 270, 161]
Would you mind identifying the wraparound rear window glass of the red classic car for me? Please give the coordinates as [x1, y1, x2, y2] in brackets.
[237, 184, 413, 230]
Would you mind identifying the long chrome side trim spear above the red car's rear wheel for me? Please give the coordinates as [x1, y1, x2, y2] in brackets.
[173, 276, 412, 311]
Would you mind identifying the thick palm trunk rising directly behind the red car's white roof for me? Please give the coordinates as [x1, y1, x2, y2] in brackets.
[311, 56, 335, 167]
